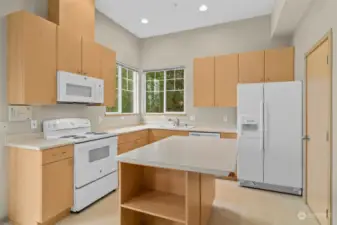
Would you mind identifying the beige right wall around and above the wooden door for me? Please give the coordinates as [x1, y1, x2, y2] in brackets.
[293, 0, 337, 225]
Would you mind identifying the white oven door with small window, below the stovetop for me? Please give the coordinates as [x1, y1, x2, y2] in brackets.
[74, 137, 117, 189]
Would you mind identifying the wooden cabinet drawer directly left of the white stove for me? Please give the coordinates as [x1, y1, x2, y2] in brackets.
[42, 145, 74, 165]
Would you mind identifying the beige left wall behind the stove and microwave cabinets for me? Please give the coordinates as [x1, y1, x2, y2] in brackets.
[0, 0, 140, 221]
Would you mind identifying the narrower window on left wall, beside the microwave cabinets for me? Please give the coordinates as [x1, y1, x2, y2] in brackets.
[106, 64, 138, 114]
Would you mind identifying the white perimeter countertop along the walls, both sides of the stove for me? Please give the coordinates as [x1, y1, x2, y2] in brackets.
[6, 124, 236, 150]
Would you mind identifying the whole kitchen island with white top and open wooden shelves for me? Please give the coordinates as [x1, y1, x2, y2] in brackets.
[117, 136, 237, 225]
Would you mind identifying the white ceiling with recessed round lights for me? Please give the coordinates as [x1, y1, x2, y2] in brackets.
[96, 0, 275, 38]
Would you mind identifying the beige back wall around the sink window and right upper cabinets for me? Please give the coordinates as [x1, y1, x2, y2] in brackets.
[141, 16, 291, 127]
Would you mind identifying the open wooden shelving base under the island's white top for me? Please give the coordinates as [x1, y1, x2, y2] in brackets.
[119, 163, 214, 225]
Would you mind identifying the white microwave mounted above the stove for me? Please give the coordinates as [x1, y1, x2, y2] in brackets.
[57, 71, 104, 103]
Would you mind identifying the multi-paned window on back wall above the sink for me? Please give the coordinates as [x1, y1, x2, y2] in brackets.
[145, 69, 185, 113]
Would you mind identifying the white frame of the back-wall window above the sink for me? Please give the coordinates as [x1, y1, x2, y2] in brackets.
[142, 67, 187, 116]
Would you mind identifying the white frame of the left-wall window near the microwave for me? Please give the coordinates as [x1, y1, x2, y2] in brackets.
[105, 63, 139, 116]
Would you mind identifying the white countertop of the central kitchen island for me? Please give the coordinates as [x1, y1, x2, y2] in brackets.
[117, 136, 237, 176]
